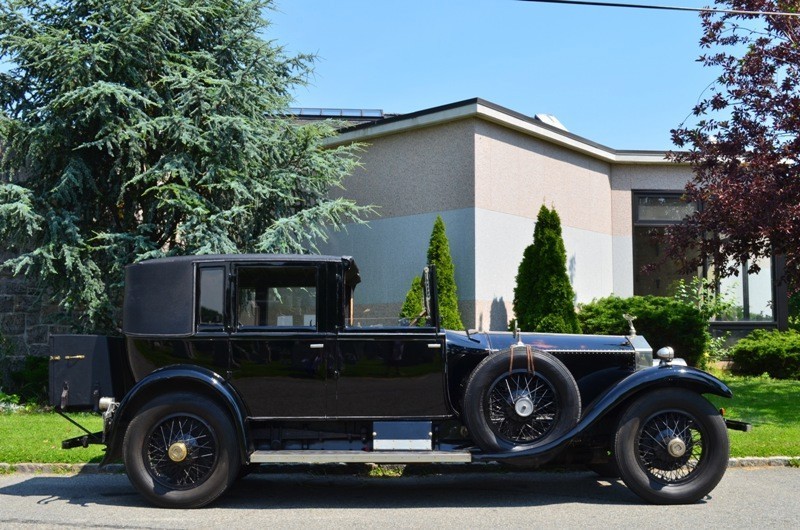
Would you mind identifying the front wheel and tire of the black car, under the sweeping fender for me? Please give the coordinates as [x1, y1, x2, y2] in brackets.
[614, 389, 730, 504]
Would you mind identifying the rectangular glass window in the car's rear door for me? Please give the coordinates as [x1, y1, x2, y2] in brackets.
[236, 267, 318, 329]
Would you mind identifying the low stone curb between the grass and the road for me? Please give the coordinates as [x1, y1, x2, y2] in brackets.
[0, 456, 800, 475]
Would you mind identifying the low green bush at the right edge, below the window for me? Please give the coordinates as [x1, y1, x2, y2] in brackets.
[731, 329, 800, 379]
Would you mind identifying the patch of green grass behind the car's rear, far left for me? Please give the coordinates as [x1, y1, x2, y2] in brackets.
[0, 412, 104, 464]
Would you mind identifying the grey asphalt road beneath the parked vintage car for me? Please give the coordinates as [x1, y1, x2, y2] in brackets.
[0, 467, 800, 530]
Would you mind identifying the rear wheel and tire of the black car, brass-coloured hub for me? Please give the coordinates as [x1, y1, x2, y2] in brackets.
[123, 393, 241, 508]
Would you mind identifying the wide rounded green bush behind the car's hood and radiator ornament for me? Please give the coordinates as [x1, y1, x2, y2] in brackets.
[578, 296, 709, 366]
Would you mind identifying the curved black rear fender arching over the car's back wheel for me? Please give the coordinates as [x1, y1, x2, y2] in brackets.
[100, 364, 248, 466]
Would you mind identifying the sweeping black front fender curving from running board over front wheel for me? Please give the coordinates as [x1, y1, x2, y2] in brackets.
[472, 365, 733, 463]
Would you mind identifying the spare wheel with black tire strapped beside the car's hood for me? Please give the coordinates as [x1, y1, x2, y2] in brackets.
[463, 348, 581, 452]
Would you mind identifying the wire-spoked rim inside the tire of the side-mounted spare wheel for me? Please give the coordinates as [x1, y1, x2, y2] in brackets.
[485, 370, 559, 445]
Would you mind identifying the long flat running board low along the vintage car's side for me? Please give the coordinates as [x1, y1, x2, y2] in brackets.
[250, 451, 472, 464]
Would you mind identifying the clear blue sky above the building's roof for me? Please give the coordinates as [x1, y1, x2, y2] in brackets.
[266, 0, 715, 149]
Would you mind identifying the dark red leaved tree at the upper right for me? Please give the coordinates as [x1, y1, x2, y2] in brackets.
[666, 0, 800, 286]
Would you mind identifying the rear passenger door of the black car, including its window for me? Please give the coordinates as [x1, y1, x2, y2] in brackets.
[230, 262, 333, 418]
